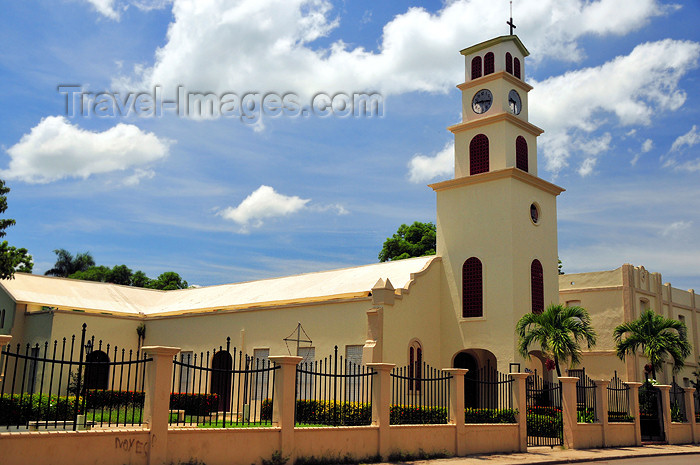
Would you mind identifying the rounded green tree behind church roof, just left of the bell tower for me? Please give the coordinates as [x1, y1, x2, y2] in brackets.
[379, 221, 436, 262]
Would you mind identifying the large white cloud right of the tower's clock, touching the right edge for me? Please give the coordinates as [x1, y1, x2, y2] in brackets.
[529, 39, 700, 175]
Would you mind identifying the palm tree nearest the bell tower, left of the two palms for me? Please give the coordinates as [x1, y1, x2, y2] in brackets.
[516, 304, 597, 376]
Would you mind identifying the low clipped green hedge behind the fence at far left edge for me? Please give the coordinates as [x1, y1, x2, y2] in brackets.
[0, 394, 82, 426]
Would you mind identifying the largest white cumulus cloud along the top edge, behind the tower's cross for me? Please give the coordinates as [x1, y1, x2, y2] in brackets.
[115, 0, 668, 99]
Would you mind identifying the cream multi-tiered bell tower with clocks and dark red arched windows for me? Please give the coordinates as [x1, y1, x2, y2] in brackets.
[430, 35, 563, 370]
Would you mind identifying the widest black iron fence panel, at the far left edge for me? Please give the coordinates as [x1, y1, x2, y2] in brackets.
[0, 324, 152, 431]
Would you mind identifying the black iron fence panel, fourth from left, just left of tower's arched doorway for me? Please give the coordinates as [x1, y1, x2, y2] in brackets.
[389, 362, 452, 425]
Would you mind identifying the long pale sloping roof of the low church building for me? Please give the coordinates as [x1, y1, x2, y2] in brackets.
[0, 256, 436, 315]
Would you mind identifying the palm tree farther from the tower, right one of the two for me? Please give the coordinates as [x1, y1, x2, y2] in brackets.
[613, 309, 692, 379]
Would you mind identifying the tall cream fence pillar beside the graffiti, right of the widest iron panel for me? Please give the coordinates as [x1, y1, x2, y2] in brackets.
[142, 346, 180, 465]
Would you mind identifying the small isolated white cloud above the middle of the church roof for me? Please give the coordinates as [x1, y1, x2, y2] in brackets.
[217, 185, 311, 233]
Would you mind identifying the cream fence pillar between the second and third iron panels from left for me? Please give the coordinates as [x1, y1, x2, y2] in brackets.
[268, 355, 303, 463]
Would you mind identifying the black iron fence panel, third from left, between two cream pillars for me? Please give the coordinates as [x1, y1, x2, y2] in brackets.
[295, 346, 375, 426]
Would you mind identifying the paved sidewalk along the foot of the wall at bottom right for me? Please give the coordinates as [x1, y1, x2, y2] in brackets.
[388, 445, 700, 465]
